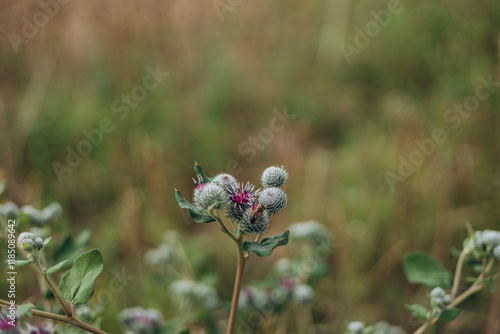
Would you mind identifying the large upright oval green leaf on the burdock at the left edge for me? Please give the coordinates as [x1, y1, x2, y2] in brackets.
[59, 249, 103, 305]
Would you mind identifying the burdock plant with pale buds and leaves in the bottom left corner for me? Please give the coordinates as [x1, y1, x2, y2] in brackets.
[0, 184, 105, 334]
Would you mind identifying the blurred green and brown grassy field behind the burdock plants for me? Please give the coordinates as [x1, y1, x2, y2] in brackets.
[0, 0, 500, 334]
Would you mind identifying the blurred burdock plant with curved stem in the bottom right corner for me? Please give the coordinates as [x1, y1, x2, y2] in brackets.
[347, 226, 500, 334]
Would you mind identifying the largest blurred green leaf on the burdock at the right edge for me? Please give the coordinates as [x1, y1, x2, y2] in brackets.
[403, 252, 453, 290]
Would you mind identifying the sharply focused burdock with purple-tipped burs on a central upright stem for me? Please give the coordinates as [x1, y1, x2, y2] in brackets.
[175, 163, 290, 334]
